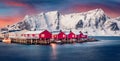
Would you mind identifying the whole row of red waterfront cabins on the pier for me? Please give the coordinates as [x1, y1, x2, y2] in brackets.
[22, 30, 88, 40]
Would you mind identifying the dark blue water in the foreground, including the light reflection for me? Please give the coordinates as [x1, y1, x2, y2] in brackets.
[0, 36, 120, 61]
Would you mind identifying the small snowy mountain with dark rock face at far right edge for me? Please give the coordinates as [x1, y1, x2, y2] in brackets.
[104, 17, 120, 36]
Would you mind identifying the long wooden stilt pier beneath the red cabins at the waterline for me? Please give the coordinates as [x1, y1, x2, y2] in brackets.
[3, 38, 98, 45]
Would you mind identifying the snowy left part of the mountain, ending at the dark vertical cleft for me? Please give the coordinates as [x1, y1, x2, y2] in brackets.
[8, 11, 59, 30]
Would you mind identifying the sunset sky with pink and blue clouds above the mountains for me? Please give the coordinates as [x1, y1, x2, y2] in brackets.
[0, 0, 120, 28]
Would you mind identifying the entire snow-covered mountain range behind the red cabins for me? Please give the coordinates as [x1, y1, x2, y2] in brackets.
[5, 9, 120, 36]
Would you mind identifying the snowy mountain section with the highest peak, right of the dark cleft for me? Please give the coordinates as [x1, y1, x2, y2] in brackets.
[61, 9, 109, 29]
